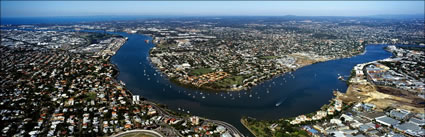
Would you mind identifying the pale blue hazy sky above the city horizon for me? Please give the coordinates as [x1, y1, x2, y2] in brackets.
[1, 1, 424, 17]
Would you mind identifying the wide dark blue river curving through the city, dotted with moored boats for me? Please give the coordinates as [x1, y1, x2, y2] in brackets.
[111, 33, 391, 135]
